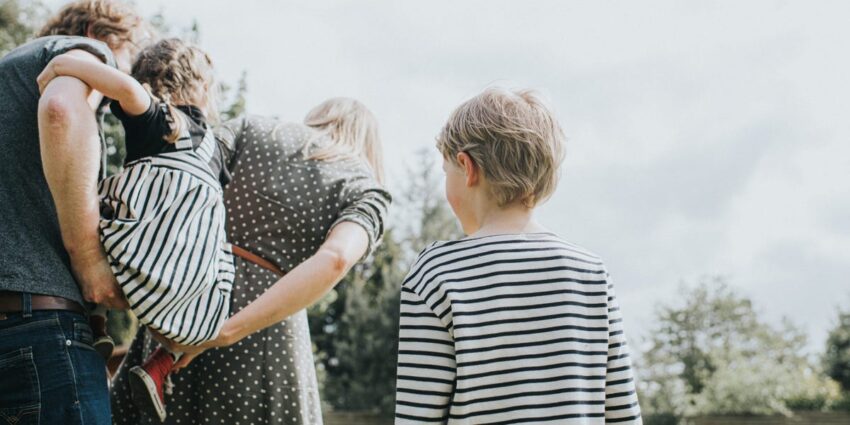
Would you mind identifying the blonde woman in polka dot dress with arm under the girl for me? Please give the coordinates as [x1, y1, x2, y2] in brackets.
[112, 99, 390, 424]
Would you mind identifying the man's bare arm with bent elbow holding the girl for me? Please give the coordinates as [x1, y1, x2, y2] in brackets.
[38, 77, 127, 308]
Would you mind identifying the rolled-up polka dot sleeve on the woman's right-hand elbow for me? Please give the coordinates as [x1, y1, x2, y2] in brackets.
[328, 177, 392, 258]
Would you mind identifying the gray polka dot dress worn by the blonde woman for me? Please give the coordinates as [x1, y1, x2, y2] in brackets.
[111, 117, 390, 425]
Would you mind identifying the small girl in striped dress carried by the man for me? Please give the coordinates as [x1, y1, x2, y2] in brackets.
[39, 39, 234, 420]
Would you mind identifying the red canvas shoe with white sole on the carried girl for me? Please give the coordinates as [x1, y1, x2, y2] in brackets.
[129, 347, 174, 422]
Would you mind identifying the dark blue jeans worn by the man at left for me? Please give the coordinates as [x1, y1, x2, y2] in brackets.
[0, 294, 112, 425]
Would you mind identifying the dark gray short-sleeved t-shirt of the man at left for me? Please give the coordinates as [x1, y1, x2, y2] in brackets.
[0, 36, 115, 303]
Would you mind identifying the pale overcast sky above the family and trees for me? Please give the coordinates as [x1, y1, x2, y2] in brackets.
[48, 0, 850, 351]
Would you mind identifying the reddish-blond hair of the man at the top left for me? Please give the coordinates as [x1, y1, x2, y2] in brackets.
[38, 0, 147, 48]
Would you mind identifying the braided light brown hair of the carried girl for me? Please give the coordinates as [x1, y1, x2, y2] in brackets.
[130, 38, 219, 143]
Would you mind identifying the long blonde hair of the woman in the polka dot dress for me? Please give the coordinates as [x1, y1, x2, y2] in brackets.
[304, 97, 384, 183]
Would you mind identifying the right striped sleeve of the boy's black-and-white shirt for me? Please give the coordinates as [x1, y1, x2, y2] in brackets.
[605, 276, 643, 424]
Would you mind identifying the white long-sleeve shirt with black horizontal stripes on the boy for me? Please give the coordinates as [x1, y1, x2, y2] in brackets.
[396, 233, 641, 424]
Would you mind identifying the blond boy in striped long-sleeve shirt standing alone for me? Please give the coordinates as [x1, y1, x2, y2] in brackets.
[396, 89, 642, 424]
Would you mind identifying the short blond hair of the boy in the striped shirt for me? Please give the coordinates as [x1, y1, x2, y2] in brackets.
[437, 88, 564, 208]
